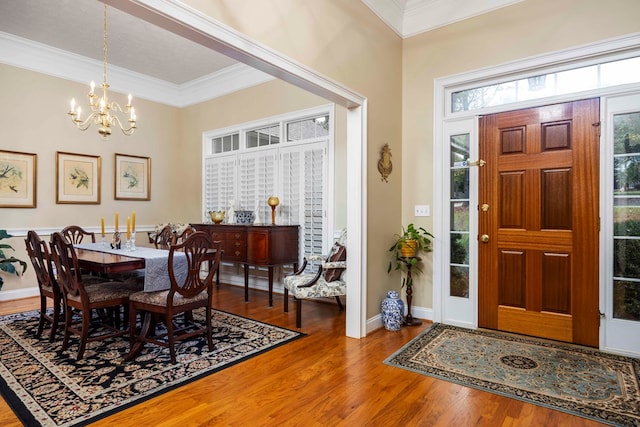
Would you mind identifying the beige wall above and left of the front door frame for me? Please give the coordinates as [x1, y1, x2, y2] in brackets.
[402, 0, 640, 307]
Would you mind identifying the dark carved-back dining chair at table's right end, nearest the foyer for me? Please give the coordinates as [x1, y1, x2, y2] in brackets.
[129, 231, 222, 364]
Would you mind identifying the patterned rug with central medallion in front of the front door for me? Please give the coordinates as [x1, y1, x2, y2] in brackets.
[384, 323, 640, 426]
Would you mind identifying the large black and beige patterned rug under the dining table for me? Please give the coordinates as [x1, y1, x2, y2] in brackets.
[0, 309, 304, 426]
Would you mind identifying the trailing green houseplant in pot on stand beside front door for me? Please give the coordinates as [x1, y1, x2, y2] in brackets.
[387, 224, 433, 287]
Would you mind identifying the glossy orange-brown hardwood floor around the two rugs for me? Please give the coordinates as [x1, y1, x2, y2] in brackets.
[0, 285, 602, 427]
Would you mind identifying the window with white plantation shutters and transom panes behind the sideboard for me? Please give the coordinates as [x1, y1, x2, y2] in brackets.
[202, 112, 333, 256]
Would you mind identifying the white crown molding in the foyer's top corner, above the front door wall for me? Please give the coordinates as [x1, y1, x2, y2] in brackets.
[362, 0, 525, 38]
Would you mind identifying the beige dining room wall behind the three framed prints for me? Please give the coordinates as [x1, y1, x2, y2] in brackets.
[0, 64, 180, 291]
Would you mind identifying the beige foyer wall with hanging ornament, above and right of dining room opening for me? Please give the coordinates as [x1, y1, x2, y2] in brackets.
[178, 0, 402, 318]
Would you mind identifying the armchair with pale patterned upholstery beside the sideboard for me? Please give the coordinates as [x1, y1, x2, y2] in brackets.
[283, 229, 347, 328]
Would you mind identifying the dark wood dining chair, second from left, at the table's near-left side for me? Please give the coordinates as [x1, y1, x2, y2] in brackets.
[50, 232, 141, 360]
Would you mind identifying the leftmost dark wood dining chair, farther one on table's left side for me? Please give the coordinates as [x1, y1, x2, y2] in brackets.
[24, 230, 64, 342]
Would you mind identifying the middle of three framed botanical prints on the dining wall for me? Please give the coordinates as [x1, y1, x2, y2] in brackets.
[56, 151, 101, 205]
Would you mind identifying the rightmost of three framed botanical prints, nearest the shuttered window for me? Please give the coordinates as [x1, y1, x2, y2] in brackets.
[114, 153, 151, 200]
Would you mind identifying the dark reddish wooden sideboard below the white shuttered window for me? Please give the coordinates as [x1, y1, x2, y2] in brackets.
[191, 224, 300, 307]
